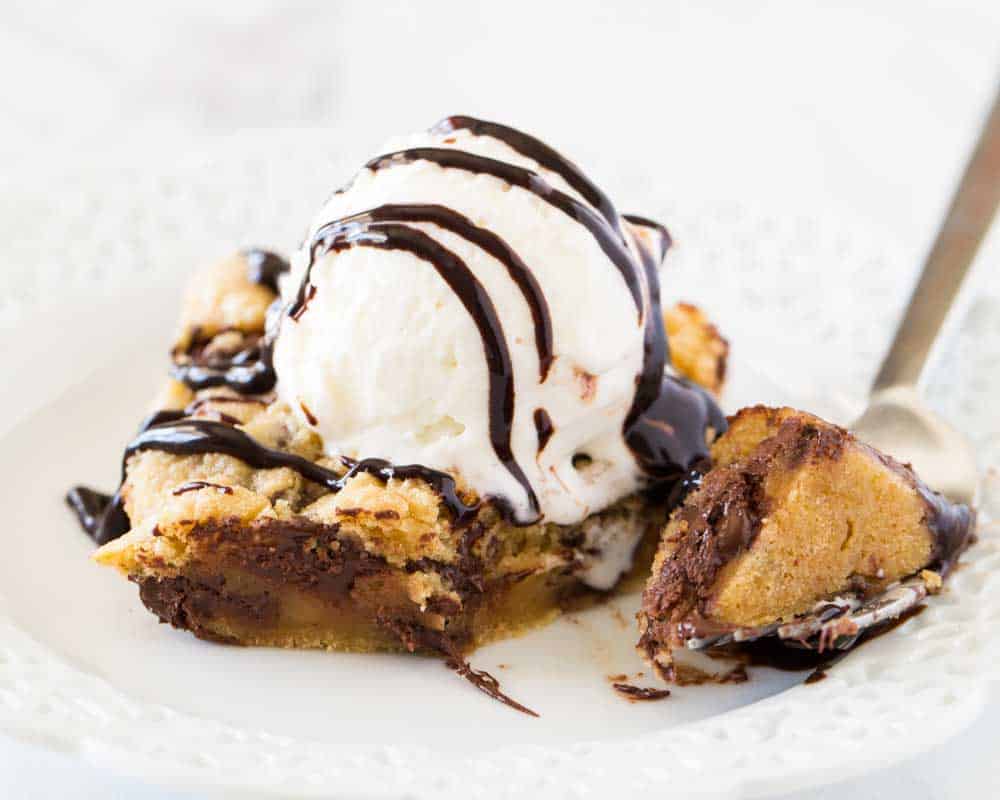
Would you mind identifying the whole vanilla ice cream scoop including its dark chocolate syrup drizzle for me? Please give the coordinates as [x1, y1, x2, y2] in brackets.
[274, 117, 724, 524]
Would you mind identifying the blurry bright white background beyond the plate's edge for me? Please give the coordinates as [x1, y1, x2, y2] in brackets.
[0, 0, 1000, 800]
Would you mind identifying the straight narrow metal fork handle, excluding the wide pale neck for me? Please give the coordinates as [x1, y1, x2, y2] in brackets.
[872, 90, 1000, 393]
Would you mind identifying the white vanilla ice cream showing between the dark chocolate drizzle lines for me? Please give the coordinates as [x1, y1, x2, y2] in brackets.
[274, 120, 659, 524]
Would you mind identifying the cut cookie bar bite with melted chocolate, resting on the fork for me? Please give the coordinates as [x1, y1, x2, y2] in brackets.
[639, 406, 974, 679]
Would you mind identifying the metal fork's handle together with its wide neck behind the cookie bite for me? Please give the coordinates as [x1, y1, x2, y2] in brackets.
[851, 90, 1000, 504]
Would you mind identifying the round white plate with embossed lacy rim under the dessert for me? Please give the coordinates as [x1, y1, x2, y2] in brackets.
[0, 141, 1000, 800]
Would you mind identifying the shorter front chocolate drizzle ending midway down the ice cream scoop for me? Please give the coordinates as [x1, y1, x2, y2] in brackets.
[315, 204, 554, 381]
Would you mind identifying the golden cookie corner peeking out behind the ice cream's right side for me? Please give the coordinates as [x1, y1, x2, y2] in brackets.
[663, 303, 729, 395]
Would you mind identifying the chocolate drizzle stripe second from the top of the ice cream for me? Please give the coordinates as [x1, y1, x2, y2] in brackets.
[365, 147, 643, 317]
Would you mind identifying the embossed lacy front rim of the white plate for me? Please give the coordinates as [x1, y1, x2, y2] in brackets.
[0, 172, 1000, 798]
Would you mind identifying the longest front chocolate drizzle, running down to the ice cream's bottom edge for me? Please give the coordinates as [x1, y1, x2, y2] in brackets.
[288, 219, 539, 524]
